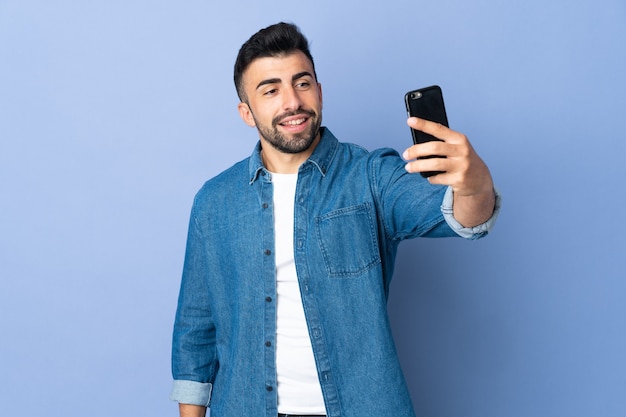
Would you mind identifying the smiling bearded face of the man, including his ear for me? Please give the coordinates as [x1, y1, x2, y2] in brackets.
[239, 51, 322, 154]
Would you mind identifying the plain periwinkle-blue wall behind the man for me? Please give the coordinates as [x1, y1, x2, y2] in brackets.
[0, 0, 626, 417]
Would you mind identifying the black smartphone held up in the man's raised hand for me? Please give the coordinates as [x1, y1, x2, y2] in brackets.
[404, 85, 449, 178]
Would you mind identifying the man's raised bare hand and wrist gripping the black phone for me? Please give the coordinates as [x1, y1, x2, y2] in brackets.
[403, 117, 495, 227]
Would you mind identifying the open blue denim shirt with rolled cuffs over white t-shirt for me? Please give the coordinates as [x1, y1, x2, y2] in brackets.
[170, 128, 495, 417]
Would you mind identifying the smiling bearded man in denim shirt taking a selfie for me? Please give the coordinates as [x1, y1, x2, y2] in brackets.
[171, 23, 499, 417]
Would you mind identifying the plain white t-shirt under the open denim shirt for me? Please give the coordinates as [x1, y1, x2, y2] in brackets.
[271, 173, 326, 414]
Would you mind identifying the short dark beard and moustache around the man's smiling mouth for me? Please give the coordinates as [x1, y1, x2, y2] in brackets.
[253, 109, 322, 154]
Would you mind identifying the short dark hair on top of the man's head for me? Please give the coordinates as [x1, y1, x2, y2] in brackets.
[234, 22, 317, 102]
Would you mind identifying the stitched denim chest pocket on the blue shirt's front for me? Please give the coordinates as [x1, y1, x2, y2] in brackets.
[315, 203, 380, 277]
